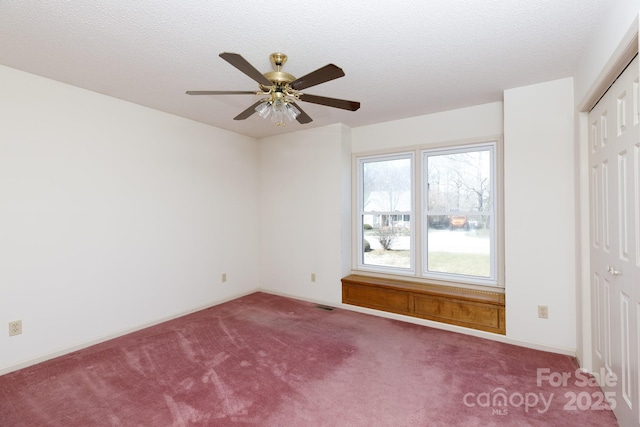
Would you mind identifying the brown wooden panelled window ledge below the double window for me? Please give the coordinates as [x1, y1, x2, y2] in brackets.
[342, 274, 506, 335]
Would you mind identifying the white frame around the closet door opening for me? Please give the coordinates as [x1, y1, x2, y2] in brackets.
[576, 15, 640, 372]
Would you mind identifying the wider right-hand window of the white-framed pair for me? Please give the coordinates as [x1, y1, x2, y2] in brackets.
[422, 145, 496, 283]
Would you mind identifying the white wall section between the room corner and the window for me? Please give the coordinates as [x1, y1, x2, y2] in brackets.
[256, 125, 351, 304]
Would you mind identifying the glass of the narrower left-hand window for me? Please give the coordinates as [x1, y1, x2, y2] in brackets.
[361, 157, 412, 269]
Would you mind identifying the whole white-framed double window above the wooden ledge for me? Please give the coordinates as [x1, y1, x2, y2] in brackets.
[355, 141, 499, 285]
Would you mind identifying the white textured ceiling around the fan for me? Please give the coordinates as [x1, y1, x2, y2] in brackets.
[0, 0, 612, 137]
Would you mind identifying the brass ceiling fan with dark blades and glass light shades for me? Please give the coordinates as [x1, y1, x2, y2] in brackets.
[187, 52, 360, 126]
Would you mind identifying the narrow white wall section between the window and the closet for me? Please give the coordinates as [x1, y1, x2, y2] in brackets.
[504, 78, 576, 350]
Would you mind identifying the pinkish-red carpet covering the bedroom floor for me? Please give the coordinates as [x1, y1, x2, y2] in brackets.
[0, 293, 617, 427]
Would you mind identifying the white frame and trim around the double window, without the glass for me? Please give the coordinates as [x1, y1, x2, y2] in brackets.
[351, 139, 504, 289]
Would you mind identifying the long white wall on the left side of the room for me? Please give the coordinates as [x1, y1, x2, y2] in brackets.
[0, 67, 258, 373]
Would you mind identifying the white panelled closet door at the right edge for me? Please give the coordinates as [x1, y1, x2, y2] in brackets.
[589, 57, 640, 426]
